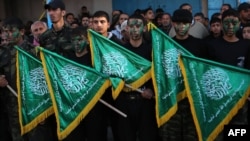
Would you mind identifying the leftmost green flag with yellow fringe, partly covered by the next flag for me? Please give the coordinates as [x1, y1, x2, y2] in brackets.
[15, 47, 54, 135]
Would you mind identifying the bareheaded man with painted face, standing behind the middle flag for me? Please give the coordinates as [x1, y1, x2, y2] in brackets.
[115, 15, 158, 141]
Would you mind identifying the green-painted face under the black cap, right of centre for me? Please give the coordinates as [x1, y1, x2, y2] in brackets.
[174, 22, 191, 36]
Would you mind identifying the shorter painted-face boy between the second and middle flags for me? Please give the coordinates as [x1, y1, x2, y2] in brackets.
[64, 26, 92, 141]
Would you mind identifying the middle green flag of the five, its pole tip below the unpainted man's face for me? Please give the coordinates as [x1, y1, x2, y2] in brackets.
[88, 30, 151, 99]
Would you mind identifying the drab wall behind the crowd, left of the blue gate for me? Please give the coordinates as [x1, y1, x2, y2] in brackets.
[0, 0, 112, 22]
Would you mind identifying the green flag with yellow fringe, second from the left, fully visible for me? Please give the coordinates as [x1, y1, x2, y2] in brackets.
[39, 48, 110, 140]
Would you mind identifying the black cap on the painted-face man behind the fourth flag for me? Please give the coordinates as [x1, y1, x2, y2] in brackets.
[172, 9, 193, 23]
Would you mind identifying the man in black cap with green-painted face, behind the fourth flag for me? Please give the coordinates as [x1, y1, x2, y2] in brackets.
[160, 9, 205, 141]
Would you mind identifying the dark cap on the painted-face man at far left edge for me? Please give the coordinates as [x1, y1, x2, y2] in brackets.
[3, 17, 24, 29]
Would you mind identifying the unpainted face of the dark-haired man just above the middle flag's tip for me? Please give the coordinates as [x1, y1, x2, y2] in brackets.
[93, 17, 110, 37]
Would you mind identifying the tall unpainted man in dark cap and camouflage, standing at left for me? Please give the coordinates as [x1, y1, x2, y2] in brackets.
[39, 0, 74, 57]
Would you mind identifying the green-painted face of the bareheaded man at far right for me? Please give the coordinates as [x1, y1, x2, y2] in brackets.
[222, 16, 240, 36]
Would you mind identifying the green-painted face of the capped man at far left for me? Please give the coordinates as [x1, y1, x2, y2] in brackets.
[3, 25, 24, 45]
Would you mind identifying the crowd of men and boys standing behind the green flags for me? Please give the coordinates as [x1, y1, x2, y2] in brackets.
[0, 0, 250, 141]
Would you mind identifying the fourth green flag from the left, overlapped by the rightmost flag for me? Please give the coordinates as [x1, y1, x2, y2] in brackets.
[148, 23, 194, 127]
